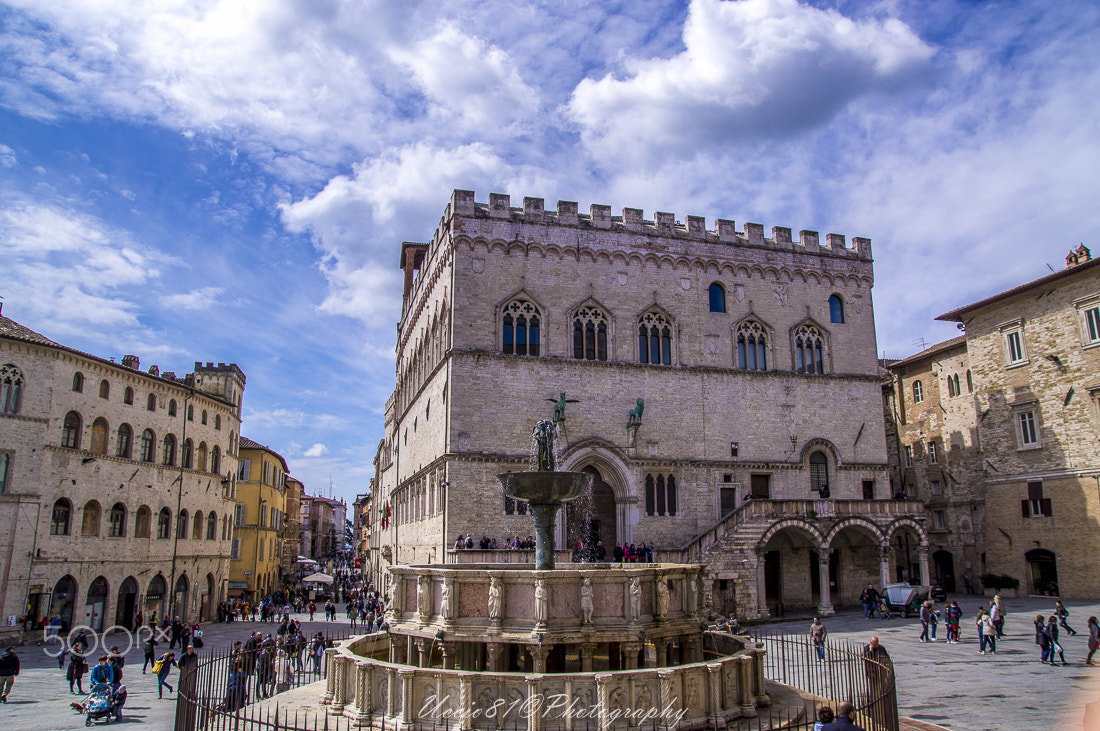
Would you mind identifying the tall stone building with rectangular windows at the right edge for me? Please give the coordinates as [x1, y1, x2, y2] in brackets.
[938, 246, 1100, 598]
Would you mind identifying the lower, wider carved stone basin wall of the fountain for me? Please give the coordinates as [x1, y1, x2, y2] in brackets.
[322, 632, 771, 731]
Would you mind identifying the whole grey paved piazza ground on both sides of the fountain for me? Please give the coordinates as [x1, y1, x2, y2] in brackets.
[0, 597, 1100, 731]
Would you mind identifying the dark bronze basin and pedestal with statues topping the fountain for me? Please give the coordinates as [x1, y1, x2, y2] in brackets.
[497, 419, 593, 571]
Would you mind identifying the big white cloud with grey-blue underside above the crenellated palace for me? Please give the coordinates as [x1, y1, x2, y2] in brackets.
[568, 0, 933, 159]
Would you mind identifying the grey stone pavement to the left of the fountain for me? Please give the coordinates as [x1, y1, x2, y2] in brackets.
[0, 612, 351, 731]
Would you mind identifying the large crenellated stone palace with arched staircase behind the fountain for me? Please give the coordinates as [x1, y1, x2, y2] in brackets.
[372, 190, 928, 616]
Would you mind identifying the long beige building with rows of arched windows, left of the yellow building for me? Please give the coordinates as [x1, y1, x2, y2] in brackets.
[0, 309, 244, 630]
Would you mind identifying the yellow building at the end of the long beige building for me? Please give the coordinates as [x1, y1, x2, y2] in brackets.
[229, 436, 287, 601]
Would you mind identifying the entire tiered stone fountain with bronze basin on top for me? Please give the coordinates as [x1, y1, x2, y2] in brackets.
[322, 420, 771, 731]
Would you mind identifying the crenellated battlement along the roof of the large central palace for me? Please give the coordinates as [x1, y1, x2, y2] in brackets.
[443, 190, 871, 262]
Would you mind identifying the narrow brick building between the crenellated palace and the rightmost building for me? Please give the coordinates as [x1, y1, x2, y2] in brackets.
[884, 335, 986, 594]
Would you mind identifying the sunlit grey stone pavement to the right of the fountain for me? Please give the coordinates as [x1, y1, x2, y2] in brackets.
[761, 596, 1100, 731]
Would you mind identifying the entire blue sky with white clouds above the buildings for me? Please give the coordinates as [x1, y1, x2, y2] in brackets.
[0, 0, 1100, 499]
